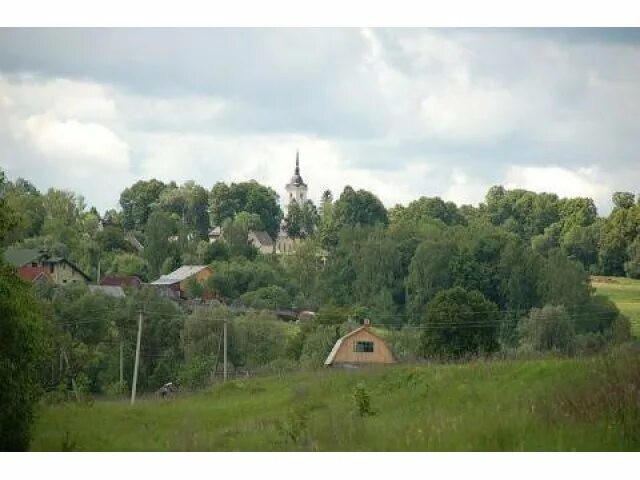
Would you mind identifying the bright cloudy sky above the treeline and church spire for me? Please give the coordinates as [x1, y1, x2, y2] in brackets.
[0, 29, 640, 213]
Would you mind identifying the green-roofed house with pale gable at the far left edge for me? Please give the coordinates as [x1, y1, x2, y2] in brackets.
[4, 248, 91, 285]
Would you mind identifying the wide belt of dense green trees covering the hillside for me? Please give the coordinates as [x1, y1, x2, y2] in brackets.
[0, 166, 640, 402]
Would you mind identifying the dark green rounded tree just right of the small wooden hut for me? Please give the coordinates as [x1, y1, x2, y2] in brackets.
[421, 287, 500, 358]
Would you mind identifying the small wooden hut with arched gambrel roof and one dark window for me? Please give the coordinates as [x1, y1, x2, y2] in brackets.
[324, 320, 395, 367]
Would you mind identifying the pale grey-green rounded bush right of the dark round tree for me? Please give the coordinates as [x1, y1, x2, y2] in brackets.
[518, 305, 576, 354]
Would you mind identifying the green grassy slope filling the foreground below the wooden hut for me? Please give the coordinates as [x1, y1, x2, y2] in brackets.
[32, 357, 640, 451]
